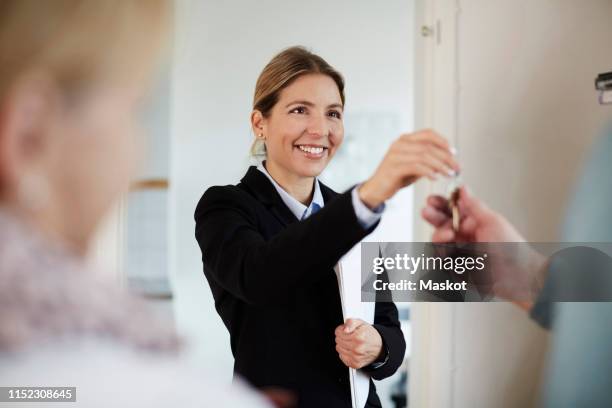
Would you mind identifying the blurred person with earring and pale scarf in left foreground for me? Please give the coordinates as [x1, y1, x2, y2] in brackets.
[0, 0, 267, 407]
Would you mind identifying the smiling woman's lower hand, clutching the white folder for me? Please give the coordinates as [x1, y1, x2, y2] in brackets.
[335, 319, 383, 369]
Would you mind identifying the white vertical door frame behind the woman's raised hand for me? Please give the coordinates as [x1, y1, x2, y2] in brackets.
[408, 0, 460, 408]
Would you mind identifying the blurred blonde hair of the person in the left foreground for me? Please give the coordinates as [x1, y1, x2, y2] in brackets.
[0, 0, 170, 100]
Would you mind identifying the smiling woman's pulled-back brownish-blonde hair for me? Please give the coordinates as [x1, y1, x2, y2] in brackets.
[251, 46, 344, 157]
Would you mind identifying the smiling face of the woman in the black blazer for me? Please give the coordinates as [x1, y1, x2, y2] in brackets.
[263, 74, 344, 177]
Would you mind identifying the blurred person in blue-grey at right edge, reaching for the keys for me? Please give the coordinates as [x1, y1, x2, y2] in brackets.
[422, 122, 612, 408]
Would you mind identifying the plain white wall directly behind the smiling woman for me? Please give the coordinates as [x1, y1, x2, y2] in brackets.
[170, 0, 413, 396]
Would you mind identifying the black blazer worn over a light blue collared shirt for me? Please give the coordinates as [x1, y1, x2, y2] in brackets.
[195, 167, 406, 408]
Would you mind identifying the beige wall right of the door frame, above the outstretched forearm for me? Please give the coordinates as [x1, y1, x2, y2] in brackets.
[459, 0, 612, 241]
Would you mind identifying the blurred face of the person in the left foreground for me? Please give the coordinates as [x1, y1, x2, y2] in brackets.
[48, 81, 145, 245]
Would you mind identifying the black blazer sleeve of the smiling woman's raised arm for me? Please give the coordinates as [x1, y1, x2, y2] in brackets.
[195, 186, 376, 305]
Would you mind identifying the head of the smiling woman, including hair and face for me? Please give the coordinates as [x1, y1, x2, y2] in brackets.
[251, 47, 345, 202]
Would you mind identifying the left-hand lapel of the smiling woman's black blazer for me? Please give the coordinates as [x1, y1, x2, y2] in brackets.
[240, 166, 298, 226]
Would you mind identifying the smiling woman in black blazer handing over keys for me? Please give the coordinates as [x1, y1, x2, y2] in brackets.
[195, 47, 458, 408]
